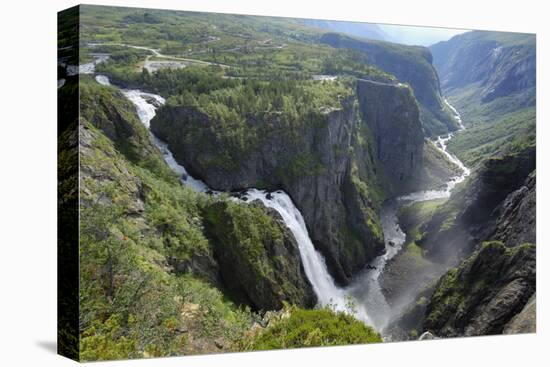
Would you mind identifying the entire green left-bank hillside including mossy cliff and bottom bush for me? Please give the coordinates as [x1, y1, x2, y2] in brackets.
[74, 77, 380, 361]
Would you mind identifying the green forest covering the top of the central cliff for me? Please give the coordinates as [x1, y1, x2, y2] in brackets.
[152, 75, 352, 174]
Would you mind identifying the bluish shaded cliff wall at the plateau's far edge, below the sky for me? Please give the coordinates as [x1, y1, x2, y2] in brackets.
[321, 33, 457, 136]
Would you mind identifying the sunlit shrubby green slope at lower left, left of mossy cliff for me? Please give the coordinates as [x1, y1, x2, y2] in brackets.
[80, 123, 253, 360]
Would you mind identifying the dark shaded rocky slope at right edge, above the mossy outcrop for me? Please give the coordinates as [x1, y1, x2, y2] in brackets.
[419, 146, 536, 262]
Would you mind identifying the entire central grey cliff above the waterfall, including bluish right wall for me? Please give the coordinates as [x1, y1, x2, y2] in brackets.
[151, 81, 423, 284]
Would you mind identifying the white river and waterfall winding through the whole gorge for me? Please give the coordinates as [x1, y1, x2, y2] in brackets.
[94, 69, 470, 334]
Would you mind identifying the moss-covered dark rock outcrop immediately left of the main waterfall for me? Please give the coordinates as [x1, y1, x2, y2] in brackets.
[204, 201, 316, 310]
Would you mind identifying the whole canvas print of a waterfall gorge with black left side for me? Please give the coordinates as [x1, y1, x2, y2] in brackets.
[57, 5, 536, 361]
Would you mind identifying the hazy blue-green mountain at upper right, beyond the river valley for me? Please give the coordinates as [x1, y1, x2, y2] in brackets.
[430, 31, 536, 167]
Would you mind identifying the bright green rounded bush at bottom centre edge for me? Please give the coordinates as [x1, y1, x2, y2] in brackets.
[243, 308, 382, 350]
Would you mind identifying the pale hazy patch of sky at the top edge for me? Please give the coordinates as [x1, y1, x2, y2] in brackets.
[377, 24, 468, 46]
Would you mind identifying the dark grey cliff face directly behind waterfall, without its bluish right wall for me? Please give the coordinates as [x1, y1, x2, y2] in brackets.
[151, 95, 383, 283]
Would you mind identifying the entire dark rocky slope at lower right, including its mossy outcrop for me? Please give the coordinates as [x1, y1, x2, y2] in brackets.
[389, 158, 536, 339]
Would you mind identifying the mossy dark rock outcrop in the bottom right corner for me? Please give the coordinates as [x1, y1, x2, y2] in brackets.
[424, 241, 536, 337]
